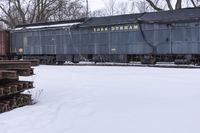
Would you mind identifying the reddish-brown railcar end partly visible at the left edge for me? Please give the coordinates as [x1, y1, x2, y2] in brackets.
[0, 30, 10, 60]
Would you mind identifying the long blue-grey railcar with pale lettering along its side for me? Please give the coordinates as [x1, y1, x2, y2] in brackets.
[11, 8, 200, 64]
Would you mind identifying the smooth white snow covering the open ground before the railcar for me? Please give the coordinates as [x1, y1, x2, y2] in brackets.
[0, 66, 200, 133]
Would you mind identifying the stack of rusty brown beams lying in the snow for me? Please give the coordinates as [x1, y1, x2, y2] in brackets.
[0, 60, 39, 113]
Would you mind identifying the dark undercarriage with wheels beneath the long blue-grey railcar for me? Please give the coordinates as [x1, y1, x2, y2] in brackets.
[15, 54, 200, 65]
